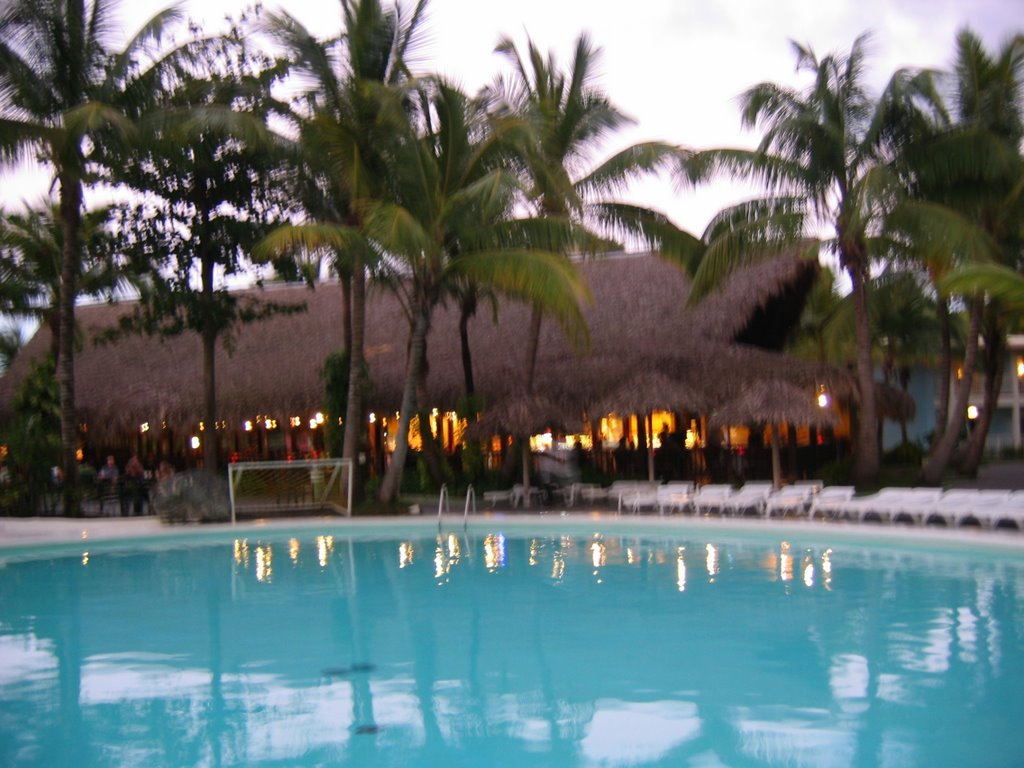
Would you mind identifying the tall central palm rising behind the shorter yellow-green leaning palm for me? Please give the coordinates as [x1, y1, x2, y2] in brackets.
[486, 35, 698, 391]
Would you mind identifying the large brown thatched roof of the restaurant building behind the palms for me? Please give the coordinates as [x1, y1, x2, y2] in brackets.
[0, 249, 852, 431]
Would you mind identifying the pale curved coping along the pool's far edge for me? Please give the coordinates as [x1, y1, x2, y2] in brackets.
[0, 510, 1024, 555]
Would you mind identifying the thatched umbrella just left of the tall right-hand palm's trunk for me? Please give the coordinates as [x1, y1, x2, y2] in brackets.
[711, 379, 839, 487]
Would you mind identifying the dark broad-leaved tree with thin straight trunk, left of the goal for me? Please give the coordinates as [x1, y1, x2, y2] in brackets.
[109, 16, 303, 473]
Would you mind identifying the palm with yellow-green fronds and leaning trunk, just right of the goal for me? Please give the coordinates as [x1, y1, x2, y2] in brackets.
[366, 82, 584, 503]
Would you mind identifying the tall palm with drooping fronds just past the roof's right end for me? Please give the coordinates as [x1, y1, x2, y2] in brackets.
[684, 35, 928, 483]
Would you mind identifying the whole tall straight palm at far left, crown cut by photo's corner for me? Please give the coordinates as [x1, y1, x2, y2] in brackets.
[0, 0, 179, 505]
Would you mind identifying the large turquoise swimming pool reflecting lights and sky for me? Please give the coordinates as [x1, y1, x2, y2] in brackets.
[0, 519, 1024, 768]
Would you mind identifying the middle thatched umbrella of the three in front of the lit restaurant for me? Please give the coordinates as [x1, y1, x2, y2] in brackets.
[595, 370, 711, 482]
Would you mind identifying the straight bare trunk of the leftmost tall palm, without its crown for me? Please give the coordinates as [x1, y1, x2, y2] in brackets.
[56, 174, 82, 516]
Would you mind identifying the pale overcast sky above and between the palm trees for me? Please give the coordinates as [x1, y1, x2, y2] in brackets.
[2, 0, 1024, 233]
